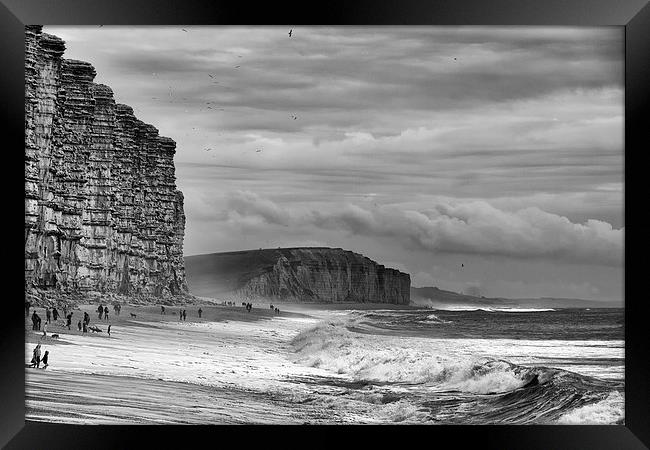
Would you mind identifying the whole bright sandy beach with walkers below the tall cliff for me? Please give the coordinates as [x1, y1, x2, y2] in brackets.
[25, 304, 410, 424]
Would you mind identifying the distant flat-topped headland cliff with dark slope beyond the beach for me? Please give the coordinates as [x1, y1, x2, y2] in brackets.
[185, 248, 411, 305]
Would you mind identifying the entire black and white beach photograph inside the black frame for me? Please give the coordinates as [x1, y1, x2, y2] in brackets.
[24, 24, 625, 425]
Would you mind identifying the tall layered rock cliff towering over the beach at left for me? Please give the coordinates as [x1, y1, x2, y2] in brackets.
[25, 26, 188, 297]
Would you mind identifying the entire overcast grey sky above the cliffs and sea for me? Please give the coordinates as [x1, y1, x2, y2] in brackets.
[43, 26, 625, 300]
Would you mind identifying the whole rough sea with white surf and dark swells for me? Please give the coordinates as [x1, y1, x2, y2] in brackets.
[292, 307, 624, 424]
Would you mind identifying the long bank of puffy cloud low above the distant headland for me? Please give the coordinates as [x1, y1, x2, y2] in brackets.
[224, 192, 624, 266]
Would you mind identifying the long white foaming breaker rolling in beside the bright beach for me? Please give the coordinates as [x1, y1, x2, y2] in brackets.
[292, 321, 540, 394]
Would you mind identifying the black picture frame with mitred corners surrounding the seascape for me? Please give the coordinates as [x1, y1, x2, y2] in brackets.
[0, 0, 650, 450]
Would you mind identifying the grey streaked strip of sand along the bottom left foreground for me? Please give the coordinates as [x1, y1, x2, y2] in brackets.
[25, 371, 324, 424]
